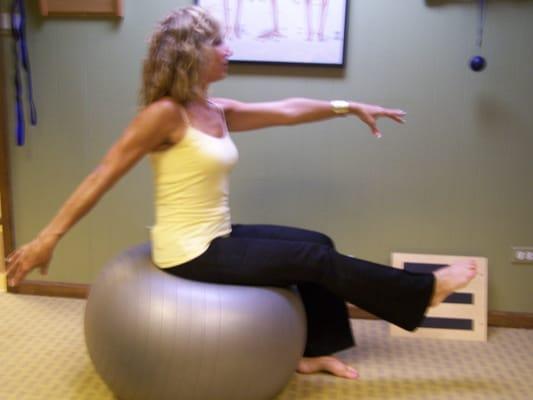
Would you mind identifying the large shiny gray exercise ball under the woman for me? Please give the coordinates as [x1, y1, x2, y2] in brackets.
[85, 244, 306, 400]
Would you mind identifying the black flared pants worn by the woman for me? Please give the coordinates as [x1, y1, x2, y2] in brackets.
[165, 225, 434, 357]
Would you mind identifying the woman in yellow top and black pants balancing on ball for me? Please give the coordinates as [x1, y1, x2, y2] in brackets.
[7, 6, 476, 378]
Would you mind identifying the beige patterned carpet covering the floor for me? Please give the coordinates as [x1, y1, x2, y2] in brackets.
[0, 294, 533, 400]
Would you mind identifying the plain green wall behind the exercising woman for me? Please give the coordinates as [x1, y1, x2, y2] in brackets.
[1, 0, 533, 312]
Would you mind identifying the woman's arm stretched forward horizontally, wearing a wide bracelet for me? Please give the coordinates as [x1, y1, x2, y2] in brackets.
[214, 98, 405, 137]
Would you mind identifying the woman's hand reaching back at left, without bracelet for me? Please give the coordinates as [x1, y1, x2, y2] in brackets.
[6, 236, 56, 286]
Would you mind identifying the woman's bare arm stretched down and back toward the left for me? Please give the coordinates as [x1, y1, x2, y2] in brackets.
[6, 100, 183, 286]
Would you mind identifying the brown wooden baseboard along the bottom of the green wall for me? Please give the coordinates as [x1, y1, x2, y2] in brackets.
[9, 281, 533, 329]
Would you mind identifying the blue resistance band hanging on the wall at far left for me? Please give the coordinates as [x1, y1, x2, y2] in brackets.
[11, 0, 37, 146]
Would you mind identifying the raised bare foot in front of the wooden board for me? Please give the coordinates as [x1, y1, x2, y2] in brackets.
[431, 260, 477, 307]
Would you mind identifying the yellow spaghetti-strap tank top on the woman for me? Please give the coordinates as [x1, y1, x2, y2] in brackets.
[151, 115, 238, 268]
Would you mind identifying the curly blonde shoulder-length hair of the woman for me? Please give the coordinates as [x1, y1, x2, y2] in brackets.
[141, 6, 221, 106]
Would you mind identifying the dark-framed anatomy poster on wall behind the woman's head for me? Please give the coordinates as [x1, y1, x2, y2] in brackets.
[195, 0, 349, 67]
